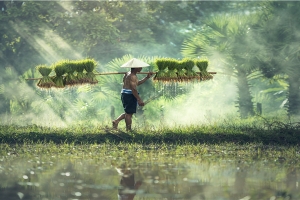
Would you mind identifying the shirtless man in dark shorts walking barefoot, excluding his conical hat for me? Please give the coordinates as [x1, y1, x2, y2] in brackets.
[112, 67, 153, 131]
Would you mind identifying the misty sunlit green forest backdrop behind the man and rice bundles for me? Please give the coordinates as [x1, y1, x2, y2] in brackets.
[0, 1, 300, 126]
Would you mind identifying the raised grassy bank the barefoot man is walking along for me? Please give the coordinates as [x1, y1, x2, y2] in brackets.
[0, 117, 300, 146]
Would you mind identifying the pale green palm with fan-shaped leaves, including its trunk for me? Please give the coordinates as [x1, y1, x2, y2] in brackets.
[182, 15, 257, 118]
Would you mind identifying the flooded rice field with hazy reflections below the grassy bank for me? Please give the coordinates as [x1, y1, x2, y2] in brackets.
[0, 145, 300, 200]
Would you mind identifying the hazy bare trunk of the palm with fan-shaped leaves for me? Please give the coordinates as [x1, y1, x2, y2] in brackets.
[237, 69, 254, 118]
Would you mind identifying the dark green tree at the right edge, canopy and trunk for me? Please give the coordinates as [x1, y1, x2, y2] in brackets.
[257, 2, 300, 116]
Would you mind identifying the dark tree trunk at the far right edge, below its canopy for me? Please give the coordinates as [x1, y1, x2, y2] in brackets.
[288, 73, 300, 116]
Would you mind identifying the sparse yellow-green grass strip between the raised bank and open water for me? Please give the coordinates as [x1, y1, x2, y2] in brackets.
[0, 142, 300, 165]
